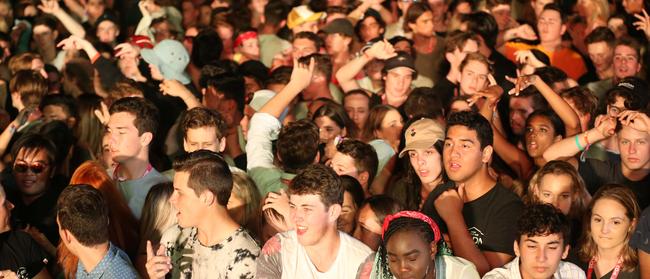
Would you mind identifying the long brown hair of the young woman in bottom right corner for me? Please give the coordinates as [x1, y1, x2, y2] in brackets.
[578, 184, 641, 271]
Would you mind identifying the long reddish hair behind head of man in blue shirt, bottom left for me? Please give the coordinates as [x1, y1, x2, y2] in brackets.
[57, 161, 139, 278]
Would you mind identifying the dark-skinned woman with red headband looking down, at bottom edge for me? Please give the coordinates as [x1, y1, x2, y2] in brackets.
[368, 211, 480, 279]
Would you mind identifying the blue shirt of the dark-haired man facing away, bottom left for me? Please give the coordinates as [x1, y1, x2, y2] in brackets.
[77, 243, 139, 279]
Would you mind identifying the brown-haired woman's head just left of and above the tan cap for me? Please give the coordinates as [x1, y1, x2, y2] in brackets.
[364, 105, 404, 152]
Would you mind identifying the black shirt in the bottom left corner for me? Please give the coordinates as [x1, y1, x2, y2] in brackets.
[0, 231, 47, 278]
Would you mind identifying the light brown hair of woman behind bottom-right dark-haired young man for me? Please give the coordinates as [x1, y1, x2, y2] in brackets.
[524, 160, 591, 220]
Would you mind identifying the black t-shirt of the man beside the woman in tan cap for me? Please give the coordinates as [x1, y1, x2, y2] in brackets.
[463, 183, 524, 256]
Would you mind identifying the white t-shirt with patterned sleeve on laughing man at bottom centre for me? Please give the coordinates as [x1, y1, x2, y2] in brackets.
[257, 230, 372, 279]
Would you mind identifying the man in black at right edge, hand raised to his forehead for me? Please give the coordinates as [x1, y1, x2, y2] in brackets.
[544, 110, 650, 208]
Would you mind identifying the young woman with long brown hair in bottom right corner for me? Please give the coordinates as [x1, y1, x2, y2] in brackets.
[579, 184, 640, 279]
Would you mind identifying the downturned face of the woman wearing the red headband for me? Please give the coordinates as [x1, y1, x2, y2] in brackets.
[386, 230, 436, 279]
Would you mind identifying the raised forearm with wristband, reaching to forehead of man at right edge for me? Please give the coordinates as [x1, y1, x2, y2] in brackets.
[543, 115, 617, 161]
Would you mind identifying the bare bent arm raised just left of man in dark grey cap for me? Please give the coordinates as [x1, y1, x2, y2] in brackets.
[336, 40, 395, 92]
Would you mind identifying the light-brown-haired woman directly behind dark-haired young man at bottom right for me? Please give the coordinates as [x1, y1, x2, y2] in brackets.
[525, 160, 591, 247]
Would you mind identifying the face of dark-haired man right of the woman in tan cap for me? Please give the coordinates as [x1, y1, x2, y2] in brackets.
[442, 125, 492, 183]
